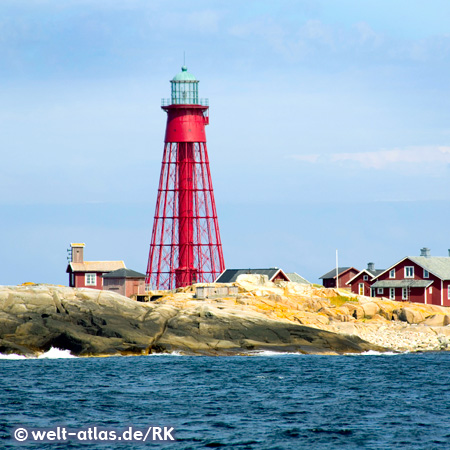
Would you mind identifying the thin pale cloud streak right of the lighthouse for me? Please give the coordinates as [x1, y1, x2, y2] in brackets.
[291, 146, 450, 171]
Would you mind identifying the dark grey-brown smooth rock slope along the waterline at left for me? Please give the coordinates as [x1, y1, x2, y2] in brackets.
[0, 286, 384, 356]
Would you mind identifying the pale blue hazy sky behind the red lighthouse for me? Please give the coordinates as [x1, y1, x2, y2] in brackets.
[0, 0, 450, 285]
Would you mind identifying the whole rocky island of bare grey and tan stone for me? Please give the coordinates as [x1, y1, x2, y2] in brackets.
[0, 275, 450, 356]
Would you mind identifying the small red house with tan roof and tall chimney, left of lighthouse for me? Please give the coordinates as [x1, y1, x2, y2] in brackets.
[66, 244, 126, 290]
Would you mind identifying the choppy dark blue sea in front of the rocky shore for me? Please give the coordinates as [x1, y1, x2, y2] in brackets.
[0, 349, 450, 450]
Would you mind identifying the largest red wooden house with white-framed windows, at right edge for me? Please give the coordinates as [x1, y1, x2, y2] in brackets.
[372, 248, 450, 306]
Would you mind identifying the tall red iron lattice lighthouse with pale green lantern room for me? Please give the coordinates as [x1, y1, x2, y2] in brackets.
[146, 66, 225, 289]
